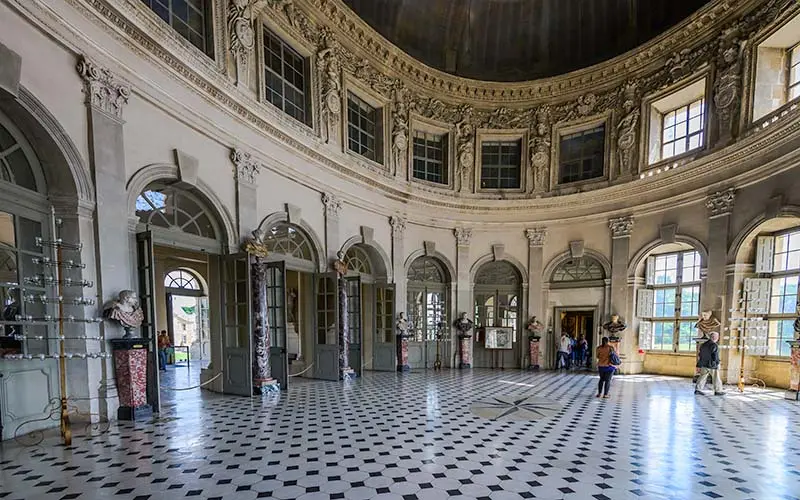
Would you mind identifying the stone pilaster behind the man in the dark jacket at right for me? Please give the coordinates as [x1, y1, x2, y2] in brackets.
[698, 189, 736, 380]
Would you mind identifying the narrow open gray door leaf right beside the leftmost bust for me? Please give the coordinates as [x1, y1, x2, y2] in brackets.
[136, 231, 161, 412]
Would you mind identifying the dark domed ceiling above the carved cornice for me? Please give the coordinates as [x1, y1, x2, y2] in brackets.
[344, 0, 707, 81]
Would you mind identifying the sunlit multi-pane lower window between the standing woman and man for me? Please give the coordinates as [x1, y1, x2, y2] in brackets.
[637, 248, 703, 354]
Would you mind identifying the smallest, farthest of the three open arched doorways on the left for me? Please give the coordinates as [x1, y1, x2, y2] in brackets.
[344, 243, 397, 374]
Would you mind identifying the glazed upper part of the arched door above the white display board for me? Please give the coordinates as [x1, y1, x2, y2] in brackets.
[475, 261, 522, 342]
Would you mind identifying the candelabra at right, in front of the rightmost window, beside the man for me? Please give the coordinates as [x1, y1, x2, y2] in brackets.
[720, 278, 769, 392]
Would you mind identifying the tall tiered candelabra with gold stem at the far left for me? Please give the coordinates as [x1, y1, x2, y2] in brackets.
[2, 208, 110, 446]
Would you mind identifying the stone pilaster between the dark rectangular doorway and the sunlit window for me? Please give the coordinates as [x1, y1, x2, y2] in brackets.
[601, 216, 635, 372]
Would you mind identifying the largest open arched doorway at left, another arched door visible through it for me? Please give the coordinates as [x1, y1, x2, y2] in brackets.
[133, 180, 233, 406]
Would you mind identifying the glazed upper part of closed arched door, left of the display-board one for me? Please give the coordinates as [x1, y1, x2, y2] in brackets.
[406, 256, 450, 342]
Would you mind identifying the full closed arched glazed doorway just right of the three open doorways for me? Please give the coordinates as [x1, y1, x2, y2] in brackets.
[406, 256, 451, 369]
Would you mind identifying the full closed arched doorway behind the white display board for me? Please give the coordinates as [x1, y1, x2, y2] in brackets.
[473, 260, 522, 368]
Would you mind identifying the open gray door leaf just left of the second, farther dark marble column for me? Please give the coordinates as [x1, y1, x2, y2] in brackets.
[314, 273, 339, 380]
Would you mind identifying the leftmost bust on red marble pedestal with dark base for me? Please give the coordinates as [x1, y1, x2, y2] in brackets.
[103, 290, 152, 420]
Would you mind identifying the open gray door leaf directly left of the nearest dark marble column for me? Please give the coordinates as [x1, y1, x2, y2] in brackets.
[222, 253, 253, 396]
